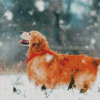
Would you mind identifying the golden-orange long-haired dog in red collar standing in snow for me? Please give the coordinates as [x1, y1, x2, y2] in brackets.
[19, 31, 100, 93]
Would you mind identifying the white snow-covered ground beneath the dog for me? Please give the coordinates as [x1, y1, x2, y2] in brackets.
[0, 74, 100, 100]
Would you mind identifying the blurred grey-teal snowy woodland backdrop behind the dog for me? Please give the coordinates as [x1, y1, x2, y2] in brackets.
[0, 0, 100, 72]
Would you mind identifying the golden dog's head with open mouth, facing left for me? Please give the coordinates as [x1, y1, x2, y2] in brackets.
[19, 31, 48, 49]
